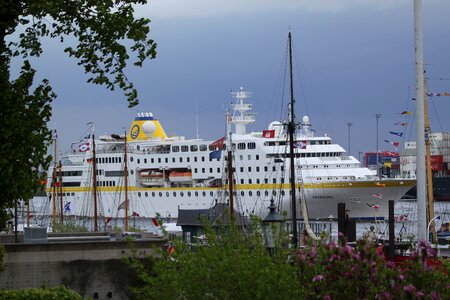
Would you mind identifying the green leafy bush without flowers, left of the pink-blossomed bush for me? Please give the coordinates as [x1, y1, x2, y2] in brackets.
[129, 218, 300, 299]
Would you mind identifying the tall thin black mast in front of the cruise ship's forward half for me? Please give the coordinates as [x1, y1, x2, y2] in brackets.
[288, 32, 298, 249]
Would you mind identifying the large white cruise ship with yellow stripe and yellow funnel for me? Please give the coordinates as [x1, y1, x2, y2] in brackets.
[37, 88, 415, 220]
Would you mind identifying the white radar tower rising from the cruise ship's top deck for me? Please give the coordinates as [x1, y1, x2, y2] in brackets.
[231, 87, 255, 134]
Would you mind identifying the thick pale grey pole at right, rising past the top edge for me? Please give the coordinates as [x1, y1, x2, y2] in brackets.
[414, 0, 427, 240]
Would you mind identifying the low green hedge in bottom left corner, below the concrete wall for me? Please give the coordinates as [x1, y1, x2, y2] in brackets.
[0, 286, 82, 300]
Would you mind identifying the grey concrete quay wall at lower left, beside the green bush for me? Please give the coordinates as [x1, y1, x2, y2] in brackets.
[0, 238, 166, 299]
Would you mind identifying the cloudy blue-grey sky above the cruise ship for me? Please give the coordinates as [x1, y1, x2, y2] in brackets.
[25, 0, 450, 158]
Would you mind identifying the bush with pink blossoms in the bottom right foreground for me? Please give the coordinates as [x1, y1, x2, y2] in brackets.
[295, 237, 450, 299]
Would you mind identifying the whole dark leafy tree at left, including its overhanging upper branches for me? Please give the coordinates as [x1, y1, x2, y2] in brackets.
[0, 0, 156, 224]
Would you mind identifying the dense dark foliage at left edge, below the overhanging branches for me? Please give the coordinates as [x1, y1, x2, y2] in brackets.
[0, 61, 55, 220]
